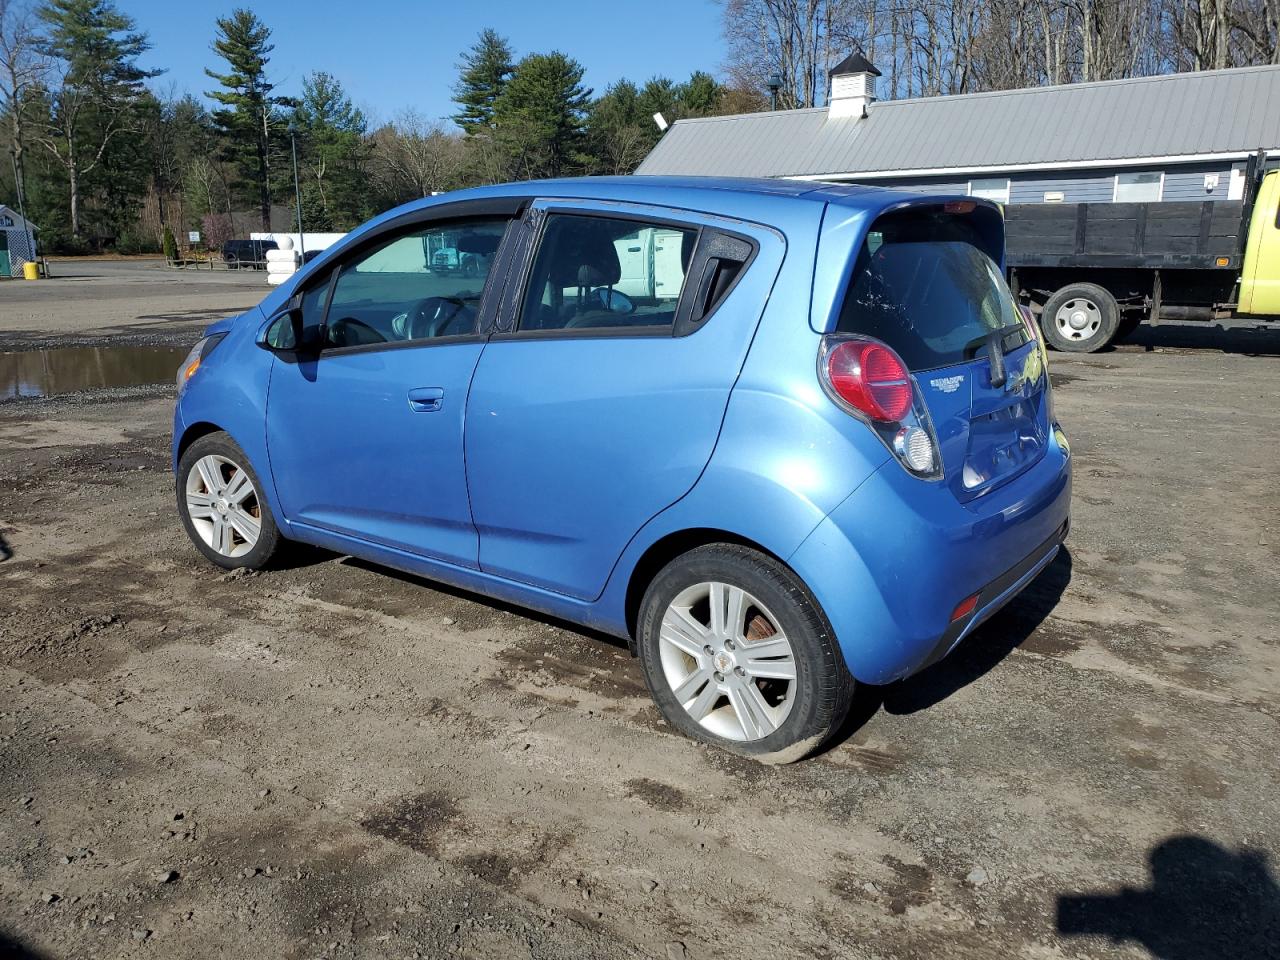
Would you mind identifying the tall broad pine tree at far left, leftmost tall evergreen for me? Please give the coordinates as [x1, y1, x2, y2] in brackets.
[36, 0, 160, 237]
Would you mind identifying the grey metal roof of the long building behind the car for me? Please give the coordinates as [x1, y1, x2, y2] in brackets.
[639, 67, 1280, 177]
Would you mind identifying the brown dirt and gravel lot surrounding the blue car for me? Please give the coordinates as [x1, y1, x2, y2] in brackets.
[0, 266, 1280, 960]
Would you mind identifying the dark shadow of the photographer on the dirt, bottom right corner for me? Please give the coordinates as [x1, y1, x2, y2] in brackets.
[1057, 836, 1280, 960]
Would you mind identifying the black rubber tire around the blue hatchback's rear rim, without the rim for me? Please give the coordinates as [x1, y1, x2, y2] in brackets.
[636, 544, 854, 764]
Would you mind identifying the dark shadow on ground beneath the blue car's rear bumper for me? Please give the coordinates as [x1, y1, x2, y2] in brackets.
[828, 545, 1071, 749]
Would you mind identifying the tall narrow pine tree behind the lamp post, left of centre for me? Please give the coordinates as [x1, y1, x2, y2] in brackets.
[205, 9, 293, 230]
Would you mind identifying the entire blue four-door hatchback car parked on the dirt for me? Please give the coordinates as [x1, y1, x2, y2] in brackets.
[173, 177, 1071, 763]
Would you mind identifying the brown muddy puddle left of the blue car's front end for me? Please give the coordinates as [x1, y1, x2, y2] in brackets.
[0, 347, 188, 401]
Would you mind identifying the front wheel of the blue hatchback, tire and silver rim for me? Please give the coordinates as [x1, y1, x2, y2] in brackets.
[177, 433, 282, 570]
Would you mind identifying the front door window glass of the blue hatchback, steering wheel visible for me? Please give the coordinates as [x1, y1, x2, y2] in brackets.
[321, 220, 507, 349]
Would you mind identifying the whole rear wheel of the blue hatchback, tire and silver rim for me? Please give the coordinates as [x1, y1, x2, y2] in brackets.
[637, 544, 854, 763]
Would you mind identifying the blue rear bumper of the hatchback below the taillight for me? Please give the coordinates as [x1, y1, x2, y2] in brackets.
[788, 427, 1071, 684]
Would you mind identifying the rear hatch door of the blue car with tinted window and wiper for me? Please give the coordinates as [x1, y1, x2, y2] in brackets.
[837, 204, 1050, 500]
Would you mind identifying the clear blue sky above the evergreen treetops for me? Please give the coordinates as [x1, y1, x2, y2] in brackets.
[132, 0, 724, 128]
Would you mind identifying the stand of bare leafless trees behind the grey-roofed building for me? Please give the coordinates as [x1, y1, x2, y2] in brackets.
[721, 0, 1280, 108]
